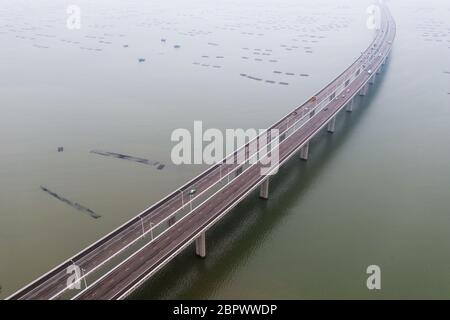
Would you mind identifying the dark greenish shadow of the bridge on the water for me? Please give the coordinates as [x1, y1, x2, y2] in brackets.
[129, 66, 389, 299]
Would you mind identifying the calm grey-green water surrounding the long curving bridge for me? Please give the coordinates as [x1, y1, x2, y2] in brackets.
[0, 0, 450, 299]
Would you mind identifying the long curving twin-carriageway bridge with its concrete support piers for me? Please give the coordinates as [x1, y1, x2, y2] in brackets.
[8, 5, 396, 300]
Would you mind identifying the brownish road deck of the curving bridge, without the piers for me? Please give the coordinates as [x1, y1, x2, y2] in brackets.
[6, 7, 395, 299]
